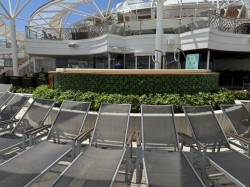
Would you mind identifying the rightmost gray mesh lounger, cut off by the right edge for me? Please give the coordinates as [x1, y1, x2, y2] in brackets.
[220, 104, 250, 156]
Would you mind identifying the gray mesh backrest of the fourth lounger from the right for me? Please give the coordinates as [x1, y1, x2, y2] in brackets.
[91, 103, 131, 148]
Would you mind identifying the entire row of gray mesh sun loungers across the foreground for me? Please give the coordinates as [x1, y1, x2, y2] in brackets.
[0, 83, 250, 187]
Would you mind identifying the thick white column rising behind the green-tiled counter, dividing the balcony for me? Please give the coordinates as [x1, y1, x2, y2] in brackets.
[155, 0, 165, 69]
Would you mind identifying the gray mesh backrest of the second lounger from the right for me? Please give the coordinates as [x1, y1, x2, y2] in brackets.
[183, 106, 230, 149]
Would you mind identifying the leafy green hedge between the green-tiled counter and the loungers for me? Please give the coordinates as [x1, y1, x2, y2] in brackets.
[29, 85, 235, 113]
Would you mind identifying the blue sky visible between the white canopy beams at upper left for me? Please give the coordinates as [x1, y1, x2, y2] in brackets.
[0, 0, 122, 32]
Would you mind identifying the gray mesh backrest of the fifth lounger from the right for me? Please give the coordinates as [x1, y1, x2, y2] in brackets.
[47, 101, 91, 143]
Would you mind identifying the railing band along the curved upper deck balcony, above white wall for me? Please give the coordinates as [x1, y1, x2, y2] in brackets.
[26, 11, 250, 40]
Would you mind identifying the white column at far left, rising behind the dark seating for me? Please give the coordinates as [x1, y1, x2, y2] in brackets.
[10, 18, 19, 76]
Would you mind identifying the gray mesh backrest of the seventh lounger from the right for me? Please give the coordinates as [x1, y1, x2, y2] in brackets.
[0, 95, 29, 121]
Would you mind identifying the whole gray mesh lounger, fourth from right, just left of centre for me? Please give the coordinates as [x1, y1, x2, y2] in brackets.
[51, 104, 131, 187]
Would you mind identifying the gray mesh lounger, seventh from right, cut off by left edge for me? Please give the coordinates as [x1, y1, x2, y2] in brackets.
[0, 95, 29, 132]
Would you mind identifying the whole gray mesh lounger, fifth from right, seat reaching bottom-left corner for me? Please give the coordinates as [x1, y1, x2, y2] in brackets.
[0, 101, 90, 187]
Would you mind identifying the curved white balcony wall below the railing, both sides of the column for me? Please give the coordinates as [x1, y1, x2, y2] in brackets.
[25, 28, 250, 56]
